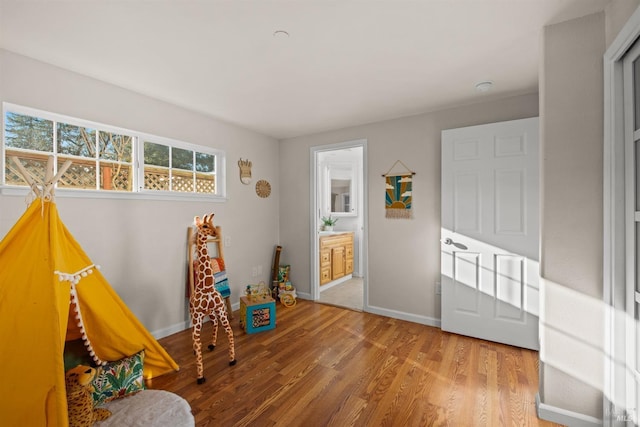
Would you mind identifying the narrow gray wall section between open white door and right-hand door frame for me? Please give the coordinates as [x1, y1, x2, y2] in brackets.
[540, 0, 640, 420]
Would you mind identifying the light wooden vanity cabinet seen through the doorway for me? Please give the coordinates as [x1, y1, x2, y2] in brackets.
[320, 233, 353, 285]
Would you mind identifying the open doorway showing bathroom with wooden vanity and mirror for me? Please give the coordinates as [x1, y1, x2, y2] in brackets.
[310, 140, 367, 311]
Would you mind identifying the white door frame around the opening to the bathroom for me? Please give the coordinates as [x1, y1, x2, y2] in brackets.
[309, 139, 369, 311]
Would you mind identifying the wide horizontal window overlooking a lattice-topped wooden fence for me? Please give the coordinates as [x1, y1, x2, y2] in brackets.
[2, 104, 224, 198]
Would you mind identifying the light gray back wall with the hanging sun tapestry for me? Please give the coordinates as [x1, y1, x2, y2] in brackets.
[280, 89, 538, 324]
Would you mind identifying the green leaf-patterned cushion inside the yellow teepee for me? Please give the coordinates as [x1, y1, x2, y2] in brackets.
[93, 350, 146, 405]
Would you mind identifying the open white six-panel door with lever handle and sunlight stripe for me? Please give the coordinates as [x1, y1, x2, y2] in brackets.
[441, 117, 539, 350]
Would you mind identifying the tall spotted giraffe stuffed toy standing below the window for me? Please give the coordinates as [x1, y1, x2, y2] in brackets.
[189, 213, 236, 384]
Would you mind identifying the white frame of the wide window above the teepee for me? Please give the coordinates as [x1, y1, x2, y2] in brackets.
[0, 102, 227, 202]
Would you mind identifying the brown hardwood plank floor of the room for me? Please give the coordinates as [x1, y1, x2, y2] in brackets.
[148, 300, 557, 427]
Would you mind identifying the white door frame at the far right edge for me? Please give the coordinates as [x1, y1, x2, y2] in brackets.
[603, 8, 640, 426]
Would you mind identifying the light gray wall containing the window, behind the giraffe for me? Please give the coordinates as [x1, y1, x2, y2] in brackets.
[0, 50, 280, 335]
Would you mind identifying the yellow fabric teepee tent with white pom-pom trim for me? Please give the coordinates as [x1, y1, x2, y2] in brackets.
[0, 160, 178, 427]
